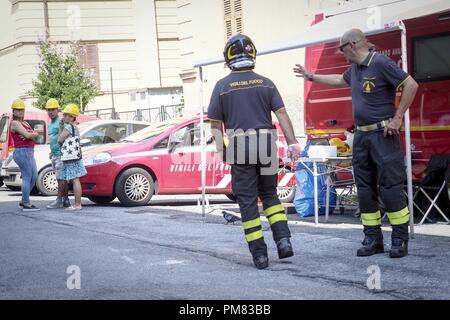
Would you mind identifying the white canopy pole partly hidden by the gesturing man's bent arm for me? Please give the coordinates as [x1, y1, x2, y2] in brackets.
[400, 21, 414, 239]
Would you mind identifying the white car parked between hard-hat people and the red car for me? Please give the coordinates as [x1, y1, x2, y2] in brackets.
[0, 120, 150, 196]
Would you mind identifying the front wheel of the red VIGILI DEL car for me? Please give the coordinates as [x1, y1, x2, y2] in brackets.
[115, 168, 154, 207]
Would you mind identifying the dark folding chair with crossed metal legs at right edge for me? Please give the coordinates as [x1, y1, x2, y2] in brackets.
[413, 155, 450, 225]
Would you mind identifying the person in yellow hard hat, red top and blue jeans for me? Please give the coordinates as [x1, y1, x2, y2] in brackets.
[10, 99, 39, 211]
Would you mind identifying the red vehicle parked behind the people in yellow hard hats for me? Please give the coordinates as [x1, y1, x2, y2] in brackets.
[0, 107, 97, 186]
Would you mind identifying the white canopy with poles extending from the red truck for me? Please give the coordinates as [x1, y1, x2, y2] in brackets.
[194, 0, 450, 236]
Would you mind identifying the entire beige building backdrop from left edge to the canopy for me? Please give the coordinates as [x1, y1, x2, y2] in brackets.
[0, 0, 357, 135]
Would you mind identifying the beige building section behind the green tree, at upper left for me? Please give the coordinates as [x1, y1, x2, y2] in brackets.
[0, 0, 183, 111]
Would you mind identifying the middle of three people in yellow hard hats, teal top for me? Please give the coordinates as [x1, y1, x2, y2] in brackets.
[45, 98, 70, 209]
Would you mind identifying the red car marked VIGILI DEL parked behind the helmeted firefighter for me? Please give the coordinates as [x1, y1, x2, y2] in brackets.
[81, 116, 295, 206]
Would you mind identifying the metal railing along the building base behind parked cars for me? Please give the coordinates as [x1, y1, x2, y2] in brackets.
[84, 104, 184, 122]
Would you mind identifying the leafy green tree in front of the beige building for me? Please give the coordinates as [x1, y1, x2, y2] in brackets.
[28, 41, 100, 111]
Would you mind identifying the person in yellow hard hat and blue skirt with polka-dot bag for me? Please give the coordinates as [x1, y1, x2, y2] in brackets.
[58, 103, 87, 210]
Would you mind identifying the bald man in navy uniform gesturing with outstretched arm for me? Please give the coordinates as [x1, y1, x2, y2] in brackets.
[294, 29, 418, 258]
